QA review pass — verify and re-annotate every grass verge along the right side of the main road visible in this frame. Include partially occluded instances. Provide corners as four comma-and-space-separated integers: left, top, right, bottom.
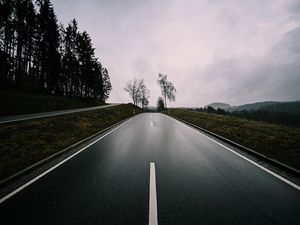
170, 109, 300, 169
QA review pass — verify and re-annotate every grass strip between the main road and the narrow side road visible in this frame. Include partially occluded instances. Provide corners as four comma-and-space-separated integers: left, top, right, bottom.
0, 104, 142, 180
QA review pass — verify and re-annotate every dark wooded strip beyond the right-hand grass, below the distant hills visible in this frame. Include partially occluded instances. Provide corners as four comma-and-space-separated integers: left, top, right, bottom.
192, 106, 300, 127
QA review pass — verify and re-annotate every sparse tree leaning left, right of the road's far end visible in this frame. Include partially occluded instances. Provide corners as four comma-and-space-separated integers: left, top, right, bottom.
157, 73, 176, 108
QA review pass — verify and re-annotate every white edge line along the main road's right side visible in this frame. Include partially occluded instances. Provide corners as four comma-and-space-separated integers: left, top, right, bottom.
177, 120, 300, 191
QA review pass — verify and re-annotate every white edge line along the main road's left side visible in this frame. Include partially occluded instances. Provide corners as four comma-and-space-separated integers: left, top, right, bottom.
0, 118, 133, 204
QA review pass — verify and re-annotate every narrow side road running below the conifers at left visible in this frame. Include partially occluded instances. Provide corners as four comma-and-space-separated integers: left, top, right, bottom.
0, 104, 120, 124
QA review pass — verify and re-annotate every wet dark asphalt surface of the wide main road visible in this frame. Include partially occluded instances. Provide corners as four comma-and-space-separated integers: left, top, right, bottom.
0, 113, 300, 225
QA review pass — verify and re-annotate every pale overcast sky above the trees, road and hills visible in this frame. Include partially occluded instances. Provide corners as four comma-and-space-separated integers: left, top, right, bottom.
52, 0, 300, 107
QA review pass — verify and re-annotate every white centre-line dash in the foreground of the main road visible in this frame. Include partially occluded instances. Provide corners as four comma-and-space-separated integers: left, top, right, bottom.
149, 162, 158, 225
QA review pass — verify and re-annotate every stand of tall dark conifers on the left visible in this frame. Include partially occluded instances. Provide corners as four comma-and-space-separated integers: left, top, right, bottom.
0, 0, 112, 102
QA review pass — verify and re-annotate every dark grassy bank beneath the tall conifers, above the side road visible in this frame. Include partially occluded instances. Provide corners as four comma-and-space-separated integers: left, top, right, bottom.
0, 90, 104, 116
